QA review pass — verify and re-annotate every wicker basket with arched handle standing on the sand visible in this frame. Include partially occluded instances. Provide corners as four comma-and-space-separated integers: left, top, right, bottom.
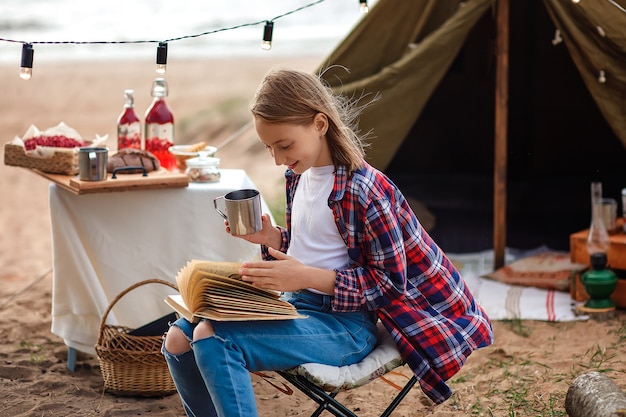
95, 279, 177, 397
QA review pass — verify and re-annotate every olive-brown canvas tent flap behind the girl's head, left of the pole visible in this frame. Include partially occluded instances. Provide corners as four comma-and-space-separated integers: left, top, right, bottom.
317, 0, 491, 170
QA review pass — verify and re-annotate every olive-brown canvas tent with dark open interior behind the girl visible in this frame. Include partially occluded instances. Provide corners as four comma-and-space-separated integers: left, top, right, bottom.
317, 0, 626, 260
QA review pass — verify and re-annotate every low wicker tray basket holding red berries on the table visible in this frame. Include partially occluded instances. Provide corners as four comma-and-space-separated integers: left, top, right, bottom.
4, 143, 78, 175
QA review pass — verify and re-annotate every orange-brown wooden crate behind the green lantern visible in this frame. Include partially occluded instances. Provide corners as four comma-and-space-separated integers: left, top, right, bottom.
569, 219, 626, 308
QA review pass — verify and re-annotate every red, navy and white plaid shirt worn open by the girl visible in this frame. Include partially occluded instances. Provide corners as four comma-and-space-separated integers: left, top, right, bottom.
263, 163, 493, 403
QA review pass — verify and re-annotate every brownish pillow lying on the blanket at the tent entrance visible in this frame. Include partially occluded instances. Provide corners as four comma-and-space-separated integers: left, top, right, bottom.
483, 251, 587, 291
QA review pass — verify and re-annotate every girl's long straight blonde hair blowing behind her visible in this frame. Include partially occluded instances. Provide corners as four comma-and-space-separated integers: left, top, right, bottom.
250, 68, 365, 172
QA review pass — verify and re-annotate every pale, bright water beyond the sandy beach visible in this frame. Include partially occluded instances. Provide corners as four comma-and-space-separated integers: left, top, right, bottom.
0, 0, 375, 65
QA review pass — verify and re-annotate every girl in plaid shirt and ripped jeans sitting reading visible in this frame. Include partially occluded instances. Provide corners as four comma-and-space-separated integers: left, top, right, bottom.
163, 69, 493, 417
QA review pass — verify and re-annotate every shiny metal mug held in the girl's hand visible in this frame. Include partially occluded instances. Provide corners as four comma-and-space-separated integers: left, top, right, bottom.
213, 189, 263, 236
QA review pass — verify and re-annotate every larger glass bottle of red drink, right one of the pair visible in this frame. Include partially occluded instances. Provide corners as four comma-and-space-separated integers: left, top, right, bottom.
144, 78, 176, 171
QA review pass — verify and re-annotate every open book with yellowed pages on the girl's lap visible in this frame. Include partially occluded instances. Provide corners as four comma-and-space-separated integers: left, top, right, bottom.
165, 260, 305, 322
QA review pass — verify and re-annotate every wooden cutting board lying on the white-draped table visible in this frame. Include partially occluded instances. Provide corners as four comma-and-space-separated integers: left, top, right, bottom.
32, 168, 189, 194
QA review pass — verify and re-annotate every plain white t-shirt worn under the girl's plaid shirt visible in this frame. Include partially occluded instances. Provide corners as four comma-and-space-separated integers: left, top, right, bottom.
287, 165, 349, 269
